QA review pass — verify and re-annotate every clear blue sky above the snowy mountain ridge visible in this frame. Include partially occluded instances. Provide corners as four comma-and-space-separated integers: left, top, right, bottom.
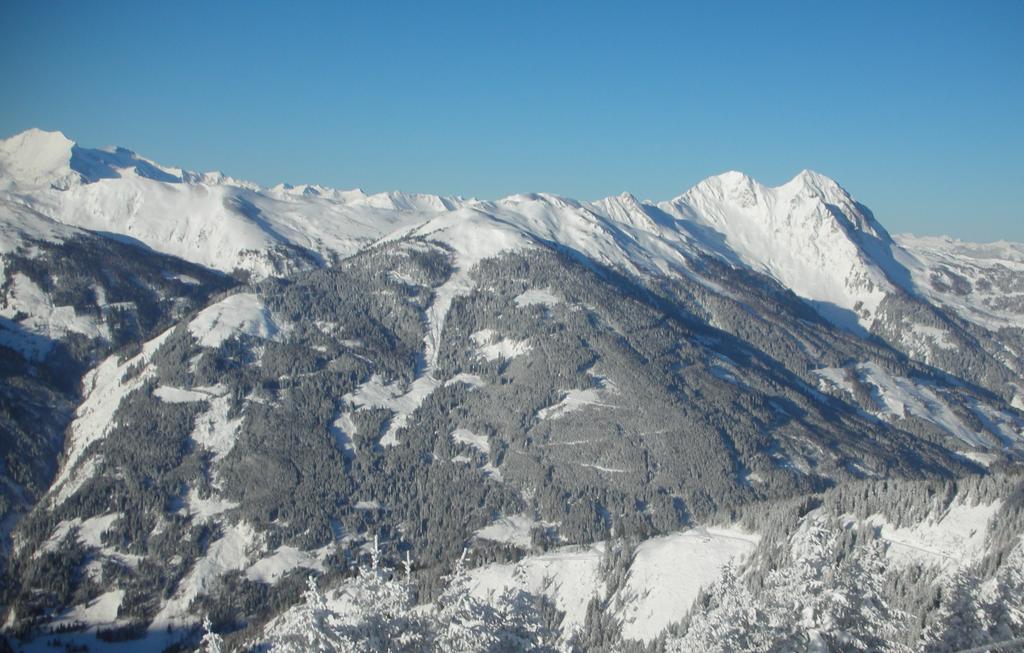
0, 0, 1024, 241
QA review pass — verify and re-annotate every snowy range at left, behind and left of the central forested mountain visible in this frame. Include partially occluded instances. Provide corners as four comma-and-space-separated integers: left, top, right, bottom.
0, 130, 459, 276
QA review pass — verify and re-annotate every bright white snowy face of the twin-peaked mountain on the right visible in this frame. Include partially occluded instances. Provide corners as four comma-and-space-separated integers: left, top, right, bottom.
658, 170, 898, 329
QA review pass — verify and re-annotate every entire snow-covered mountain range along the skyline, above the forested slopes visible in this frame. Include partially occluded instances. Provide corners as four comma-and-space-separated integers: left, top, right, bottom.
0, 130, 1024, 398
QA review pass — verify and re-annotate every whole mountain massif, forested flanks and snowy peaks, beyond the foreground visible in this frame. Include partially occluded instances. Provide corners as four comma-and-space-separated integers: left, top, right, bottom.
0, 131, 1024, 650
